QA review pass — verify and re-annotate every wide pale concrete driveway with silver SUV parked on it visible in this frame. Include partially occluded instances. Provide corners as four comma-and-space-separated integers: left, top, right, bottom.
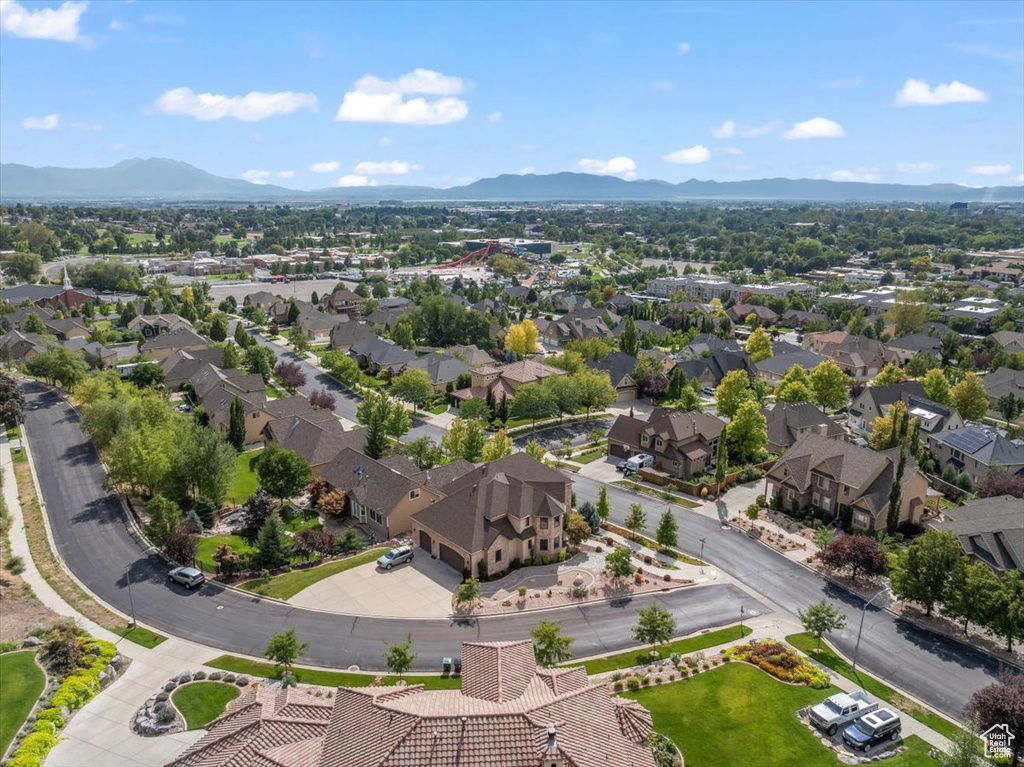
288, 551, 462, 617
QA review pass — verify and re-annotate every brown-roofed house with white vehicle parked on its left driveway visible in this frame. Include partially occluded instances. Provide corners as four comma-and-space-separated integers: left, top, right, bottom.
608, 408, 725, 479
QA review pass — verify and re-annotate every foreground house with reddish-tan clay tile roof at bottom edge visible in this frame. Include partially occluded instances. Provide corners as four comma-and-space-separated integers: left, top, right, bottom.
167, 639, 655, 767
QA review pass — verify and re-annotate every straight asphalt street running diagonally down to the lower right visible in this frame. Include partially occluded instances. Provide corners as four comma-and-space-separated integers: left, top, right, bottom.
565, 472, 1001, 717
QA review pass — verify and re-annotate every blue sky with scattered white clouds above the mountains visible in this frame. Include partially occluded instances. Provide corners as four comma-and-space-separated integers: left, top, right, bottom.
0, 0, 1024, 188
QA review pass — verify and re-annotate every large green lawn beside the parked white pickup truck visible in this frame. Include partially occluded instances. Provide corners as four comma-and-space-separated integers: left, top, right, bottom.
626, 663, 938, 767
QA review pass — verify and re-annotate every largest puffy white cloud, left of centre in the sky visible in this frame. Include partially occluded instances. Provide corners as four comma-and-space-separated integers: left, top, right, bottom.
334, 70, 469, 125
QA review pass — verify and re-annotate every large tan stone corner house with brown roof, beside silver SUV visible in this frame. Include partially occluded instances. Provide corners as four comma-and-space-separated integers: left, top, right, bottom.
412, 453, 572, 574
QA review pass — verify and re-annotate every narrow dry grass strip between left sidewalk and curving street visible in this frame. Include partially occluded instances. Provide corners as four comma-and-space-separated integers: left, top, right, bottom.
14, 454, 167, 647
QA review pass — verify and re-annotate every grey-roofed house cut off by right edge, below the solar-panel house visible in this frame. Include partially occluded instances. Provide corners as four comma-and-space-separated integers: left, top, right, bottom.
932, 496, 1024, 572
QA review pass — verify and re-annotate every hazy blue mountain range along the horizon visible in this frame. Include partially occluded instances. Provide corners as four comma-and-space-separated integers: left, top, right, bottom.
0, 158, 1024, 203
